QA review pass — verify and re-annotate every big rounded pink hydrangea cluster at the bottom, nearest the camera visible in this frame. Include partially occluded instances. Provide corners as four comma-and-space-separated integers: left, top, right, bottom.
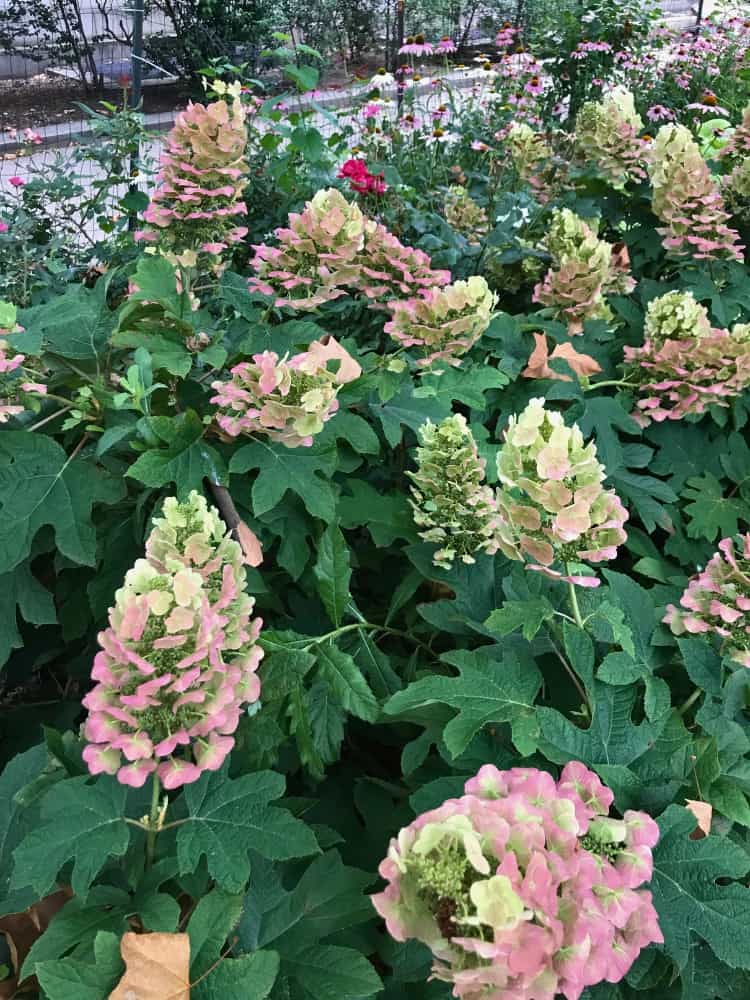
372, 761, 663, 1000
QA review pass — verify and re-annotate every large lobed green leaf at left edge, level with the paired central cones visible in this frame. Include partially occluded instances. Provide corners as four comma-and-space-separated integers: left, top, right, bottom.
0, 430, 123, 573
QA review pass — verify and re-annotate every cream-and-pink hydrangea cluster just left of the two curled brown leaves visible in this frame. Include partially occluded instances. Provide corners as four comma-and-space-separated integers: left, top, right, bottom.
384, 274, 497, 367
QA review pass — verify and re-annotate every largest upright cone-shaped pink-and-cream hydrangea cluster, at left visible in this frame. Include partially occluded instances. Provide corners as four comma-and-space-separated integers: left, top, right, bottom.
83, 490, 263, 789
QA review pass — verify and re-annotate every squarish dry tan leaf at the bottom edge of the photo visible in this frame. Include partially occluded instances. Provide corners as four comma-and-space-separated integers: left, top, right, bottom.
109, 932, 190, 1000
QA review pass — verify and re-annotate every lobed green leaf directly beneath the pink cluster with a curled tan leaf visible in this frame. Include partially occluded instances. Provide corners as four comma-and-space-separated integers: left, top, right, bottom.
229, 441, 337, 522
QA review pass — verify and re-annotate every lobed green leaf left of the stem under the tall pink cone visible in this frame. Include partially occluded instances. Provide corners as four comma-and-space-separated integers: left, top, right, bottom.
13, 776, 130, 899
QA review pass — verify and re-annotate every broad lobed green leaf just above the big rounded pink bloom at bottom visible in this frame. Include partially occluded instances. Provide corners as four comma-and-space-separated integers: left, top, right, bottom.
384, 649, 542, 757
